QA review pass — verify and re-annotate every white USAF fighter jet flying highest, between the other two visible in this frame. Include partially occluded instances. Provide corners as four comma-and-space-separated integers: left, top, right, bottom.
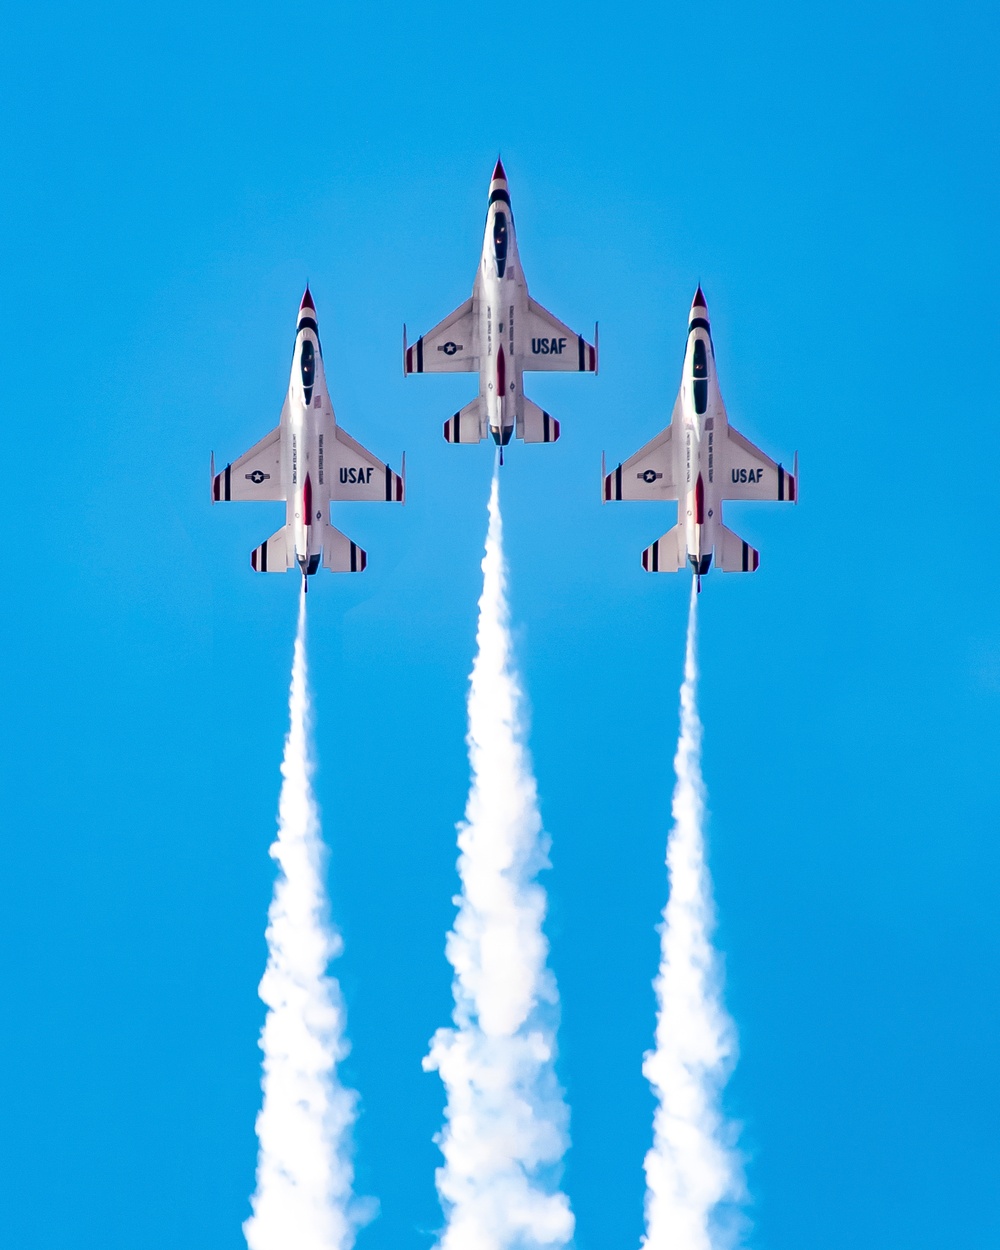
403, 160, 598, 464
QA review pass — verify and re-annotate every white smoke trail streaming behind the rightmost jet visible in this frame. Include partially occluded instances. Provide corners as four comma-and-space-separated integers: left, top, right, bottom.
643, 583, 745, 1250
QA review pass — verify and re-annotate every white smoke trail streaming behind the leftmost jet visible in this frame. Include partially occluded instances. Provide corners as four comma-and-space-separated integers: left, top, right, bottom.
244, 591, 361, 1250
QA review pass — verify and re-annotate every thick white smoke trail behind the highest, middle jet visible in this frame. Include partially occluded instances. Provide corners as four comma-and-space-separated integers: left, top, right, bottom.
424, 469, 574, 1250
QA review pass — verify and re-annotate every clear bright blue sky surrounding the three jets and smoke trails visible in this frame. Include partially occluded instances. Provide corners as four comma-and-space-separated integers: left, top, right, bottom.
0, 0, 1000, 1250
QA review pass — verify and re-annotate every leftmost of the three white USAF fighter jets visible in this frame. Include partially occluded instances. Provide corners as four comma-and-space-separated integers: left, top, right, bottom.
211, 286, 406, 590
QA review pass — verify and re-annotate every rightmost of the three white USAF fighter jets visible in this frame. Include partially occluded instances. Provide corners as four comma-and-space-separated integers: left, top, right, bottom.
601, 286, 799, 590
